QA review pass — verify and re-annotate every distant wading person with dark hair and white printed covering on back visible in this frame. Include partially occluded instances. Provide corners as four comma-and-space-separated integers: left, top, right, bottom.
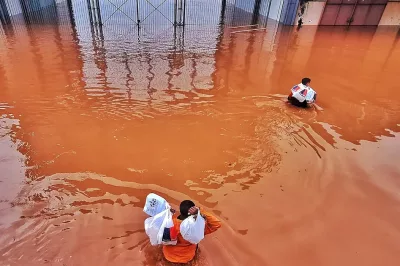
288, 78, 317, 107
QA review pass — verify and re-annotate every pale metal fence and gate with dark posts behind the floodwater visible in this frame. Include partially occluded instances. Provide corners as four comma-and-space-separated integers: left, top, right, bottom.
0, 0, 274, 27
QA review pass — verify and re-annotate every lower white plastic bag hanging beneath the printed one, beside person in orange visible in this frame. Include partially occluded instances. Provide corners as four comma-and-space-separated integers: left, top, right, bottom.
144, 207, 177, 246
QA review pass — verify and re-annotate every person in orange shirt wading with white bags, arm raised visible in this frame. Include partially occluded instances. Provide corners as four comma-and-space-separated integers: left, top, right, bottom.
163, 200, 221, 263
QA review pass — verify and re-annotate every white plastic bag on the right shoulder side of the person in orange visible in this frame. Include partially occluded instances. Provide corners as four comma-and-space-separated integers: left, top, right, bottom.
180, 210, 206, 244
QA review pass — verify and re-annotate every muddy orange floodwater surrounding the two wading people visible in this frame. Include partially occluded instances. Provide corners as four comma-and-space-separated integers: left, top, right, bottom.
0, 20, 400, 266
